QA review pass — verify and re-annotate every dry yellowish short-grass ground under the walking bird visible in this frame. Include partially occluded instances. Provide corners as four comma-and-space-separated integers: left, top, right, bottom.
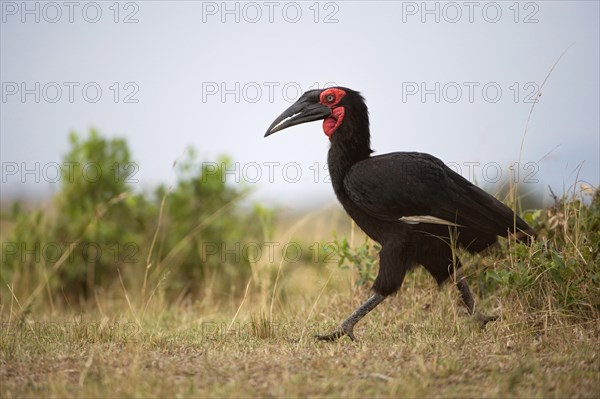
0, 266, 600, 397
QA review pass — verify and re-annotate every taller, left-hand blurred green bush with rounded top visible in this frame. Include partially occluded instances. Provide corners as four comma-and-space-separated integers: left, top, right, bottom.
53, 130, 149, 297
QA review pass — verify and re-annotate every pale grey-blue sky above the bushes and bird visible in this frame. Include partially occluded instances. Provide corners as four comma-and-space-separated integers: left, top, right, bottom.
0, 1, 600, 208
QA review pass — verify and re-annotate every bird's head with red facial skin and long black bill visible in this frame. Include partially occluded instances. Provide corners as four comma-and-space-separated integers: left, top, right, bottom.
265, 87, 368, 139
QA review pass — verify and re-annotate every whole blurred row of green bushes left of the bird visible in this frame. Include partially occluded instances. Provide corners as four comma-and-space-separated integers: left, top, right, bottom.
0, 130, 271, 301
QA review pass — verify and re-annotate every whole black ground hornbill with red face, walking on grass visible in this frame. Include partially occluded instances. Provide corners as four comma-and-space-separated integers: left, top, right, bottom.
265, 87, 535, 341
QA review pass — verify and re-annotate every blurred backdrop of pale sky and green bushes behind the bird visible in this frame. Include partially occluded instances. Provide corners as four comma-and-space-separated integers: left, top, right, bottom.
0, 1, 600, 309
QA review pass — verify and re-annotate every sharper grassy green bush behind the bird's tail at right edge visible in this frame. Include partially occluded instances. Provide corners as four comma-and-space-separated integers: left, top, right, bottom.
479, 190, 600, 315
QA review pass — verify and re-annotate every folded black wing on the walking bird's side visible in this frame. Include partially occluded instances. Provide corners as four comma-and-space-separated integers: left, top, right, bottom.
344, 152, 533, 236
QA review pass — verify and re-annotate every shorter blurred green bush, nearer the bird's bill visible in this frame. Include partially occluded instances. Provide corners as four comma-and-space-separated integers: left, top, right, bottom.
151, 151, 271, 291
